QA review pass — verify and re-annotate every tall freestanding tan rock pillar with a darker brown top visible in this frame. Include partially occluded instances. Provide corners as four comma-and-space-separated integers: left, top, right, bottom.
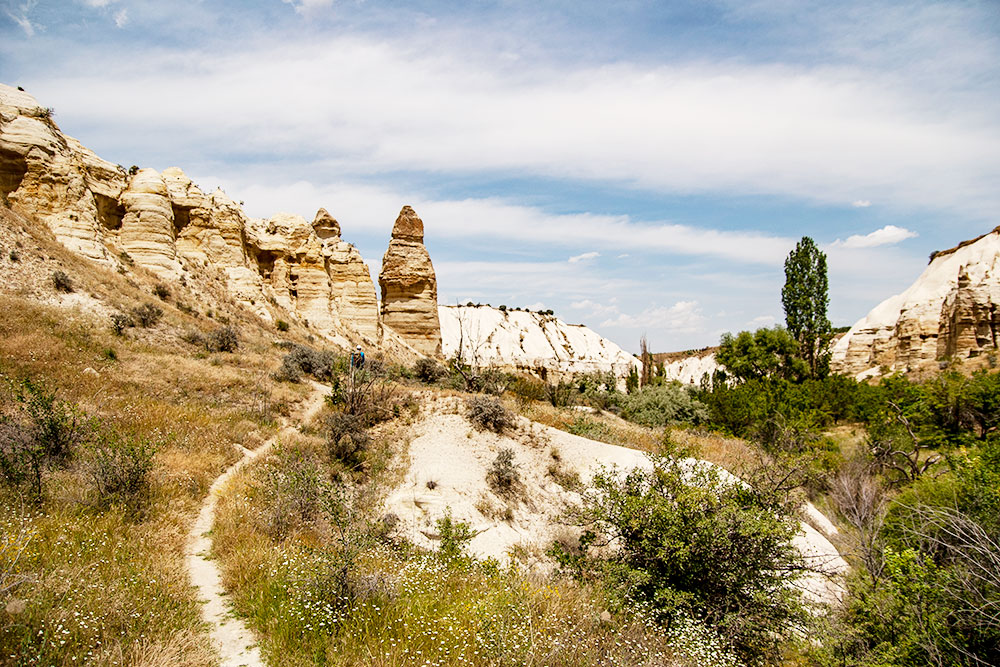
378, 206, 441, 356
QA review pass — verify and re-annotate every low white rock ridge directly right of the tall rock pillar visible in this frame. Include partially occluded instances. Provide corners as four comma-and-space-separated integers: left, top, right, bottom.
438, 306, 642, 380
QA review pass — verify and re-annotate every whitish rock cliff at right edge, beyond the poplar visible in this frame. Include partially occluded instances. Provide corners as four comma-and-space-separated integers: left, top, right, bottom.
830, 227, 1000, 377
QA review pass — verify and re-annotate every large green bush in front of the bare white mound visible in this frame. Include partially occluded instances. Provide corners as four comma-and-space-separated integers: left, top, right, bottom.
553, 456, 809, 664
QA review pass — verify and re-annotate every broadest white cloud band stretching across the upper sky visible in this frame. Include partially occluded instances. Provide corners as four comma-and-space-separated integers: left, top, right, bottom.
34, 34, 1000, 215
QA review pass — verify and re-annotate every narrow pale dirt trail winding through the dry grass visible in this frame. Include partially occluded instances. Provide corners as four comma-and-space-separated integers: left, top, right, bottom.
185, 382, 328, 667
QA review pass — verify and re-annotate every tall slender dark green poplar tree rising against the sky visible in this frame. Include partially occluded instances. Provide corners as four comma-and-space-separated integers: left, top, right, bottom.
781, 236, 833, 377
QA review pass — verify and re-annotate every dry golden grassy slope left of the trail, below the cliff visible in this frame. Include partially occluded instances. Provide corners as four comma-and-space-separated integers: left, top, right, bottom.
0, 207, 320, 665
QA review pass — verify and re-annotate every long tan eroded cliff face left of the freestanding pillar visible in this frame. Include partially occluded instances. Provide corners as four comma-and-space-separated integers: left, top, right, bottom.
0, 84, 378, 343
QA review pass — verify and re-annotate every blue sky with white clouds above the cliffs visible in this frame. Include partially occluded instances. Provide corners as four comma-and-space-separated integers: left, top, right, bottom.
0, 0, 1000, 352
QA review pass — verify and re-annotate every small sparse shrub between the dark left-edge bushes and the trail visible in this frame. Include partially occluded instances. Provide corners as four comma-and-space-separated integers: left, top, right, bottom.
85, 433, 156, 504
